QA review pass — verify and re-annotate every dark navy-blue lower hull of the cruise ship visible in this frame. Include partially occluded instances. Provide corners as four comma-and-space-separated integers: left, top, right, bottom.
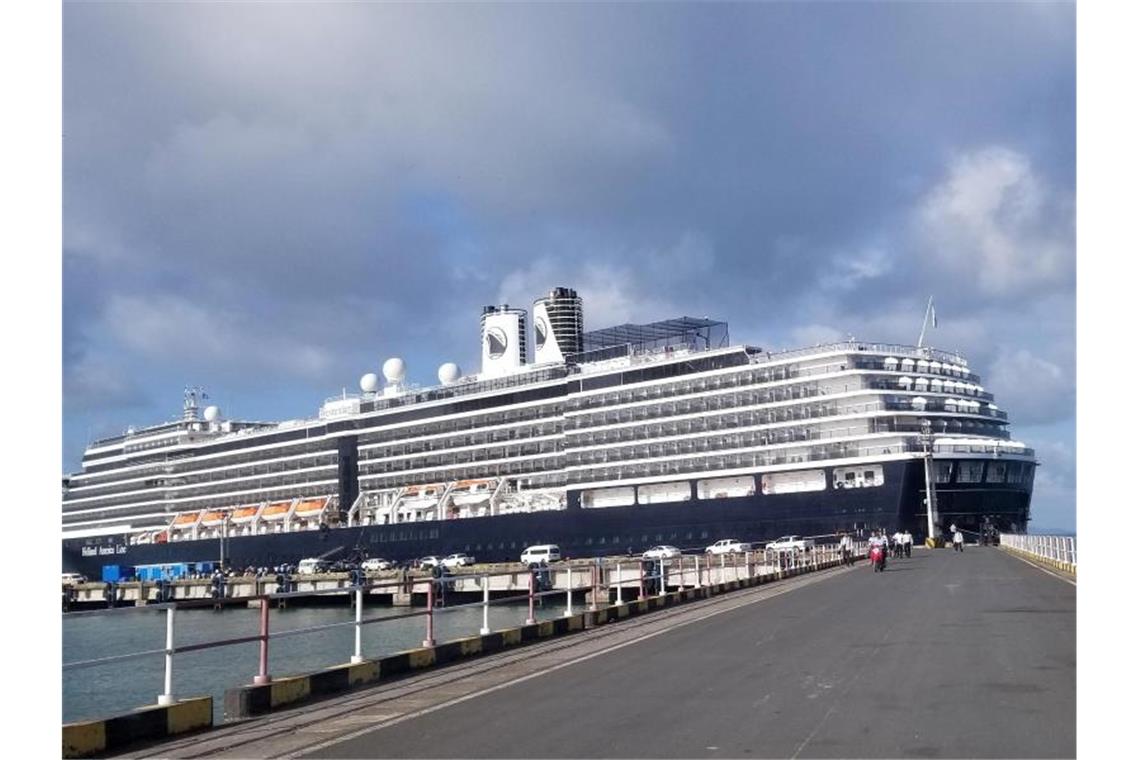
63, 460, 1033, 578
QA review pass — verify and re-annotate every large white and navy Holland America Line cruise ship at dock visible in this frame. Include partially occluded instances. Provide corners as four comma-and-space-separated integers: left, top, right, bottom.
63, 287, 1036, 575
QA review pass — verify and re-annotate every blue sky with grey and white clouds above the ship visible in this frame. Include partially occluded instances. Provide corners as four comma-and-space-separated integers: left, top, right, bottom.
62, 2, 1076, 530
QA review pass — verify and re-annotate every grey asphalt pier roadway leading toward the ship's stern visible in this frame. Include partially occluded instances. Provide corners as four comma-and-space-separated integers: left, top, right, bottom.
140, 547, 1076, 758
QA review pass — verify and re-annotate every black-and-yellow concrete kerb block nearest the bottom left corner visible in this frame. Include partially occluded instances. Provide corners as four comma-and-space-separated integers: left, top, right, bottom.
63, 696, 213, 758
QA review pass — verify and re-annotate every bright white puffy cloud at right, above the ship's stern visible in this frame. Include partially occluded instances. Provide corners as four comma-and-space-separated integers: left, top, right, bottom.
914, 146, 1075, 297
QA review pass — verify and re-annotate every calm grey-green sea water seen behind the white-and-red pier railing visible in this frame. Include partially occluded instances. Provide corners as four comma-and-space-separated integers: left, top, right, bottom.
63, 597, 583, 725
